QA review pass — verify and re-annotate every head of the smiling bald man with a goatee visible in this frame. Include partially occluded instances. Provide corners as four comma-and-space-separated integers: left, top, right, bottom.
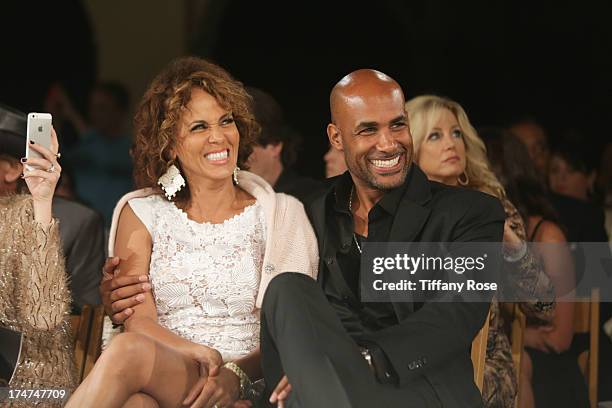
327, 69, 412, 191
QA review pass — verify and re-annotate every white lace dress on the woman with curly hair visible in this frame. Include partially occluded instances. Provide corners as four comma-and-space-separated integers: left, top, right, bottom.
129, 195, 266, 361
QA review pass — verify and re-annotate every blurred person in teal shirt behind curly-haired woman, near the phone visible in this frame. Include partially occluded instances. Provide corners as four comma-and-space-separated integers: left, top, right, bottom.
59, 82, 133, 228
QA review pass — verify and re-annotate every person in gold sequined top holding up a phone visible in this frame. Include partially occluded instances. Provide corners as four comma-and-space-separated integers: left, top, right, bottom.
0, 124, 76, 398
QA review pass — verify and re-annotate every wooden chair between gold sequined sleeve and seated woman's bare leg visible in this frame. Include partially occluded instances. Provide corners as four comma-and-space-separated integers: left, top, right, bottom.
70, 305, 104, 383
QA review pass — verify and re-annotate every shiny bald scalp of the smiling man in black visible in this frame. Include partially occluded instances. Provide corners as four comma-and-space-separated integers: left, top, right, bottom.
329, 69, 404, 123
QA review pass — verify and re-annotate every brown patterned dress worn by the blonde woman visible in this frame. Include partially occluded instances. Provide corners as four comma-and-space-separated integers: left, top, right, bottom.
482, 198, 554, 408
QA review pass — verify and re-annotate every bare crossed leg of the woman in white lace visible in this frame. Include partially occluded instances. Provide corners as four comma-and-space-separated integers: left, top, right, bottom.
66, 333, 199, 408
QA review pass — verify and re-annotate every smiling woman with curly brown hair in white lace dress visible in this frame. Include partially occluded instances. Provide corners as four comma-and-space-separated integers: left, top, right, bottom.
68, 57, 318, 407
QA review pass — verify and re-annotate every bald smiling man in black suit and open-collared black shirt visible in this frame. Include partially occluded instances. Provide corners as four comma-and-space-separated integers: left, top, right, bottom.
261, 70, 504, 408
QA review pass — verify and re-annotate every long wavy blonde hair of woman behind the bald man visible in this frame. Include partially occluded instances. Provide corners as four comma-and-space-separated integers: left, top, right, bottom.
406, 95, 506, 198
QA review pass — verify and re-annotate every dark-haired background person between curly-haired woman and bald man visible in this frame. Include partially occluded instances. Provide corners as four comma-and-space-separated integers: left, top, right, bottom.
246, 87, 322, 202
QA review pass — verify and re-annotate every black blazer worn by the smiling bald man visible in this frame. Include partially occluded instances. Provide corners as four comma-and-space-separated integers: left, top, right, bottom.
307, 165, 505, 407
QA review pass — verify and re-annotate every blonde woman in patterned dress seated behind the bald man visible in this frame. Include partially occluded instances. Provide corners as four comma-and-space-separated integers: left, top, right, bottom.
406, 95, 554, 407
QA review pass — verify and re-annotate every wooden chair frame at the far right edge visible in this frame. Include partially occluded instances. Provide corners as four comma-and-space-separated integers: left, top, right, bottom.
574, 288, 599, 408
